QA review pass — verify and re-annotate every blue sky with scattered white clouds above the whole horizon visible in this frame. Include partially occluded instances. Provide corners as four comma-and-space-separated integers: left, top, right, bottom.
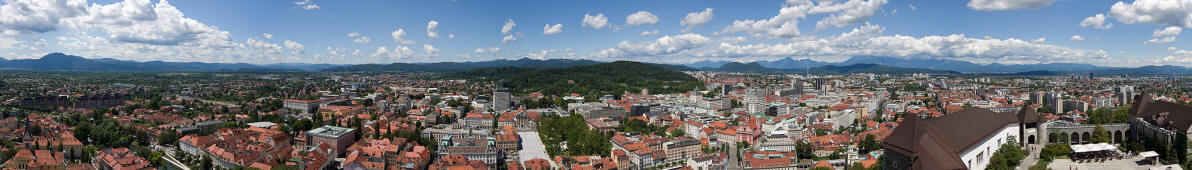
0, 0, 1192, 67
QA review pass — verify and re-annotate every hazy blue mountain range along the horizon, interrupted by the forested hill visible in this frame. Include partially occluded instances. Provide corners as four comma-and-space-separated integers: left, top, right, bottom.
0, 52, 1192, 75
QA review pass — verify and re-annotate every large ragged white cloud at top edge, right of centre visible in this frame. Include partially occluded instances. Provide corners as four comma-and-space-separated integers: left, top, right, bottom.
719, 0, 887, 38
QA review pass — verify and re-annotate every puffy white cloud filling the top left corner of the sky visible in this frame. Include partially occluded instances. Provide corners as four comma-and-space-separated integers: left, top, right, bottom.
0, 0, 87, 32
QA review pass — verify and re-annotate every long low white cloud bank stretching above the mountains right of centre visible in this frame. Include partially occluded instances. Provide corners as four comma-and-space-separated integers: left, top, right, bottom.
702, 25, 1107, 63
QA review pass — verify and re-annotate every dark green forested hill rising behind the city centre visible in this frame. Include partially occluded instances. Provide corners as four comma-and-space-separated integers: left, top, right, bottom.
507, 61, 703, 97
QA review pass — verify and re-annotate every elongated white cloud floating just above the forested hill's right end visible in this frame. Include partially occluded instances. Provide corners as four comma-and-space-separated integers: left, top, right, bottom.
597, 33, 710, 57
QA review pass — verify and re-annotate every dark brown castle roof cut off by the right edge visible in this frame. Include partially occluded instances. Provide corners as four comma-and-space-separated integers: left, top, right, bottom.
1130, 93, 1192, 132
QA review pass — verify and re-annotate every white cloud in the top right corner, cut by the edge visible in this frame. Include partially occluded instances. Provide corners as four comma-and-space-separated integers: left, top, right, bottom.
1109, 0, 1192, 27
